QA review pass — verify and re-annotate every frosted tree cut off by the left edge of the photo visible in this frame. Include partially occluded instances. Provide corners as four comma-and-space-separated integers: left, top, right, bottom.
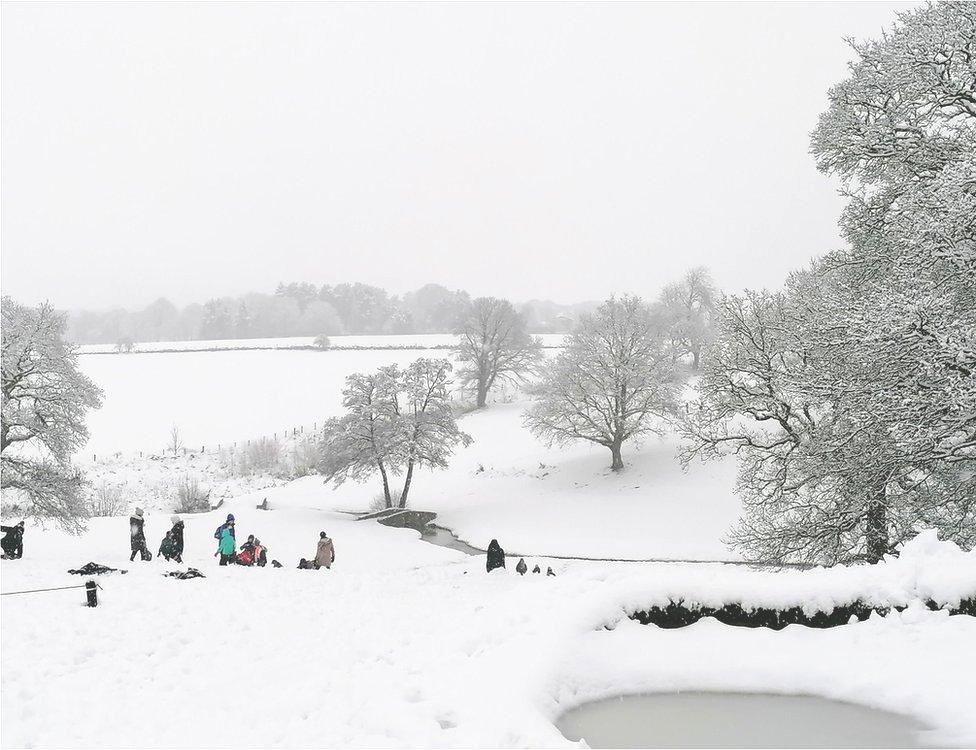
0, 296, 101, 531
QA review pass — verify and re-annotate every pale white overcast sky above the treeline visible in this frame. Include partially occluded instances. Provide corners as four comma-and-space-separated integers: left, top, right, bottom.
2, 3, 912, 308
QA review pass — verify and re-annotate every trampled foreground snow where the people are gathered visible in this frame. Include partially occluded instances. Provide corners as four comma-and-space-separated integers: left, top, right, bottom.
0, 478, 976, 748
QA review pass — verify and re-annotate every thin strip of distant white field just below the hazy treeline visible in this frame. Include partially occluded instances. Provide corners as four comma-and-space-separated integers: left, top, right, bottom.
78, 333, 564, 354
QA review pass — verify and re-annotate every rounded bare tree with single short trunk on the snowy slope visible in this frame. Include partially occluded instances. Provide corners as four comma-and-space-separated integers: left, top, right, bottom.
524, 297, 676, 471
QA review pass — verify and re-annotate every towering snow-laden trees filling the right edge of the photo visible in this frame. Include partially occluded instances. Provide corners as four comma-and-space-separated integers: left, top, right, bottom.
686, 2, 976, 562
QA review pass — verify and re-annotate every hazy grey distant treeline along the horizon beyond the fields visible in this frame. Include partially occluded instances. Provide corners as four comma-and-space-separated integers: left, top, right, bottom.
68, 282, 595, 344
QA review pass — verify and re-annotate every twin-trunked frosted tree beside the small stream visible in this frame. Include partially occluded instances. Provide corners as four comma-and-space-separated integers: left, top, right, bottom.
320, 358, 471, 508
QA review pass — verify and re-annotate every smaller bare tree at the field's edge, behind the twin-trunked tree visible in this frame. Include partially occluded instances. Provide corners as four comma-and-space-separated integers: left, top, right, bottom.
454, 297, 542, 408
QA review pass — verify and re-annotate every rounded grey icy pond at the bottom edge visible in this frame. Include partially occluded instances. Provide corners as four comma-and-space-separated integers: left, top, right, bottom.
556, 692, 933, 748
